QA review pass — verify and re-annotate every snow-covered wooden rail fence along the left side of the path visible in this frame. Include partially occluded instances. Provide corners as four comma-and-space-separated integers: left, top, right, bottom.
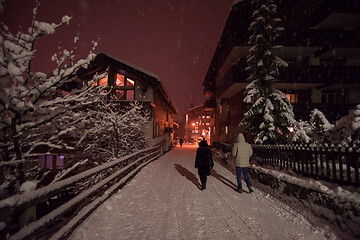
0, 145, 161, 239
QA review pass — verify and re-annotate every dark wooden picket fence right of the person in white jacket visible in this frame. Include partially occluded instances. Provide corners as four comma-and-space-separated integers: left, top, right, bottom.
252, 145, 360, 187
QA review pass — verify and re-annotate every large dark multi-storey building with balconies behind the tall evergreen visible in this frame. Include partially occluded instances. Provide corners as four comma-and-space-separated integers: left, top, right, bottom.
203, 0, 360, 144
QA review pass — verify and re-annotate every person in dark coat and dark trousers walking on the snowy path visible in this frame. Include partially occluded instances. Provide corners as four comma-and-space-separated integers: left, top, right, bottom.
195, 139, 214, 190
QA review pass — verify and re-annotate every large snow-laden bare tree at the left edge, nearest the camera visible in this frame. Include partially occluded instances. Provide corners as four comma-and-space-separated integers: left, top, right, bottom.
0, 2, 97, 187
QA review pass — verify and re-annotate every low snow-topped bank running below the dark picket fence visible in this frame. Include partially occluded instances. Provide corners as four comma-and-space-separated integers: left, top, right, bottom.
249, 165, 360, 239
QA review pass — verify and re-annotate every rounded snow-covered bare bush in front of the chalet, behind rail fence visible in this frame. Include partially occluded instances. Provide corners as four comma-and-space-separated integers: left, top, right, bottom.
74, 96, 149, 164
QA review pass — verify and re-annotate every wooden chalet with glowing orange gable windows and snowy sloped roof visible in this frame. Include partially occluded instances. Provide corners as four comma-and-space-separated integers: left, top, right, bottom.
77, 53, 178, 151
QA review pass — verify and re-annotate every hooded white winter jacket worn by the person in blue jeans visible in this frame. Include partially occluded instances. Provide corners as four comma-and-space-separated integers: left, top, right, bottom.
232, 133, 252, 167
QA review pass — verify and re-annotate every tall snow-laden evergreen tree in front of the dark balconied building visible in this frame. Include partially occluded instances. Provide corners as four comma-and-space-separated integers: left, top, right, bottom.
241, 0, 295, 143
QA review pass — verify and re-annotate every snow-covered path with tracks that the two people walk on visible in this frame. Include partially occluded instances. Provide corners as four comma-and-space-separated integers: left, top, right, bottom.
70, 145, 336, 240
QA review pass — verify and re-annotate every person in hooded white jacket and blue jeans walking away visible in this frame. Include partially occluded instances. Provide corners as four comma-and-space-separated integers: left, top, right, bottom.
232, 133, 253, 193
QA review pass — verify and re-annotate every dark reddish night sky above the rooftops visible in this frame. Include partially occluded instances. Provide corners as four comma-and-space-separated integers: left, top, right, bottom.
1, 0, 234, 119
